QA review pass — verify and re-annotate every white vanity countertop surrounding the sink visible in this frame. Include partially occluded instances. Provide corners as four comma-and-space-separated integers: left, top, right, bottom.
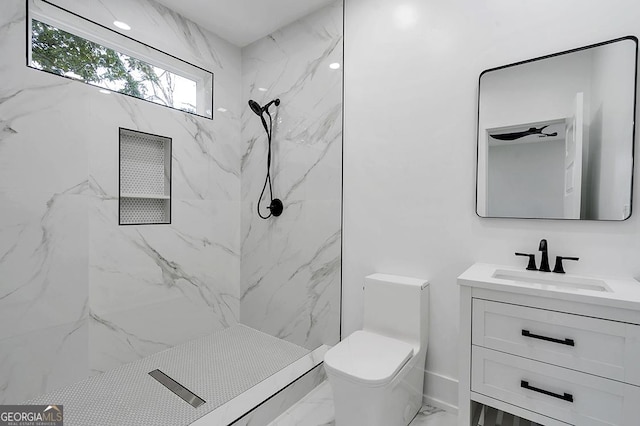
458, 263, 640, 310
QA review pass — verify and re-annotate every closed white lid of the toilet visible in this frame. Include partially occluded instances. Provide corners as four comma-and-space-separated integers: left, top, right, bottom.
324, 330, 413, 384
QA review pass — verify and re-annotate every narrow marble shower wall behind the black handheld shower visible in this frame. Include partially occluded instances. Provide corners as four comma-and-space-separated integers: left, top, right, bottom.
240, 1, 343, 349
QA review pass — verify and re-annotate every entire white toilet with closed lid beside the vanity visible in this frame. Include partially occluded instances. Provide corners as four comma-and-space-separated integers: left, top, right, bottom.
324, 274, 429, 426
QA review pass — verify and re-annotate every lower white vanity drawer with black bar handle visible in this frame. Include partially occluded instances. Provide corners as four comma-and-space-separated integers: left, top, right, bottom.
471, 346, 640, 426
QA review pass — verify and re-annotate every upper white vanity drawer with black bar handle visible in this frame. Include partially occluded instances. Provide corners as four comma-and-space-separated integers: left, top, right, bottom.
472, 299, 640, 385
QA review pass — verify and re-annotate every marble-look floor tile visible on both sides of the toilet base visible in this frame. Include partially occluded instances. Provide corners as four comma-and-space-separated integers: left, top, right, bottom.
269, 381, 458, 426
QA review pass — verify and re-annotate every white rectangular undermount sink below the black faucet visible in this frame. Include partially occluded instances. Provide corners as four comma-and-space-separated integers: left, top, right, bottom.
492, 269, 612, 292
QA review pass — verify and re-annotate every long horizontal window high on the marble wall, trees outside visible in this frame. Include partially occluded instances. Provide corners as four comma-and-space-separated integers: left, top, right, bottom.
28, 1, 213, 118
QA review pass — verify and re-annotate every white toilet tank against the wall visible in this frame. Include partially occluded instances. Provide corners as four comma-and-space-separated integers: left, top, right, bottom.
363, 274, 429, 350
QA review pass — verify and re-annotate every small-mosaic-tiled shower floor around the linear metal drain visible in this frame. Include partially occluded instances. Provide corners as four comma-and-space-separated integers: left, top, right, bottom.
28, 325, 309, 426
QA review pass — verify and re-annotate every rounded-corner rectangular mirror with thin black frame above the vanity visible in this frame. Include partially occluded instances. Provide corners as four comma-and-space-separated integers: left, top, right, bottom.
476, 36, 638, 220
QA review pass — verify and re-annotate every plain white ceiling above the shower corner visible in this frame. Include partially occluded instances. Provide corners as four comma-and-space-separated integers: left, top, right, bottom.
156, 0, 335, 47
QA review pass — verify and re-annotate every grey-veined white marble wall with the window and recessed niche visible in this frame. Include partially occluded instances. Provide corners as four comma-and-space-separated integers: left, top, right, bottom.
0, 0, 241, 404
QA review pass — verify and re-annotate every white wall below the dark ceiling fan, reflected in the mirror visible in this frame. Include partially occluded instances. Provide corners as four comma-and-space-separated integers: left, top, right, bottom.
487, 139, 565, 217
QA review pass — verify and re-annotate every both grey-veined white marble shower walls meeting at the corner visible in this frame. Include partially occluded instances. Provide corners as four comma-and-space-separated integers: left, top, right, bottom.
0, 0, 342, 403
